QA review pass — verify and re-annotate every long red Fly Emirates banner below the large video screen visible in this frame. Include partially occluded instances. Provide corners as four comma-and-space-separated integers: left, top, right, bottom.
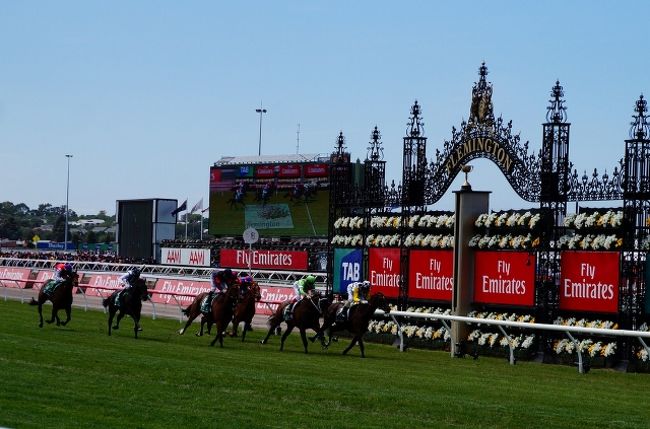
219, 249, 308, 271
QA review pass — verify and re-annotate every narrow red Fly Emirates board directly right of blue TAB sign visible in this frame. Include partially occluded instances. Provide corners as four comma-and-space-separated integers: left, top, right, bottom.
368, 247, 400, 298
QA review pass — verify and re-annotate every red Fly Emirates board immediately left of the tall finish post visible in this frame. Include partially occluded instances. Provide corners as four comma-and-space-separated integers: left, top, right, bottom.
408, 250, 454, 302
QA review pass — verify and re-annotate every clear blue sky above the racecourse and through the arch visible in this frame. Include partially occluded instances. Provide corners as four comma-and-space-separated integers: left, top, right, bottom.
0, 0, 650, 214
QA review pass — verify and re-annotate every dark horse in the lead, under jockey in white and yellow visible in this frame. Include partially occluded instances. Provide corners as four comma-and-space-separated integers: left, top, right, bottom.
310, 292, 390, 358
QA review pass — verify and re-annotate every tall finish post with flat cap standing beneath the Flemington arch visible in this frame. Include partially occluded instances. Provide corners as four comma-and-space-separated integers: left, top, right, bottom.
451, 186, 490, 357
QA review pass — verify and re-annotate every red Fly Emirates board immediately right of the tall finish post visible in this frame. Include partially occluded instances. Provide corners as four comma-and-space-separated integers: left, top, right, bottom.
474, 252, 536, 307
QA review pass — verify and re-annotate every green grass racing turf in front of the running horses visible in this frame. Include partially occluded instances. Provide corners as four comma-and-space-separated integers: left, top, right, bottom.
0, 301, 650, 428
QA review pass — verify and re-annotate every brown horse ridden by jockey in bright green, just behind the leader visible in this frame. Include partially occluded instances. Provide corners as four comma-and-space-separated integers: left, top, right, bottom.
261, 292, 327, 353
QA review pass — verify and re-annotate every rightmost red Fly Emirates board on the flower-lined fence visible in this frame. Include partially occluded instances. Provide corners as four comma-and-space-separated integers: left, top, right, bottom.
560, 251, 620, 313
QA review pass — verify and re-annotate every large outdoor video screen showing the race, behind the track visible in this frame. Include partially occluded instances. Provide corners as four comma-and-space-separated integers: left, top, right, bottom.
209, 163, 329, 237
